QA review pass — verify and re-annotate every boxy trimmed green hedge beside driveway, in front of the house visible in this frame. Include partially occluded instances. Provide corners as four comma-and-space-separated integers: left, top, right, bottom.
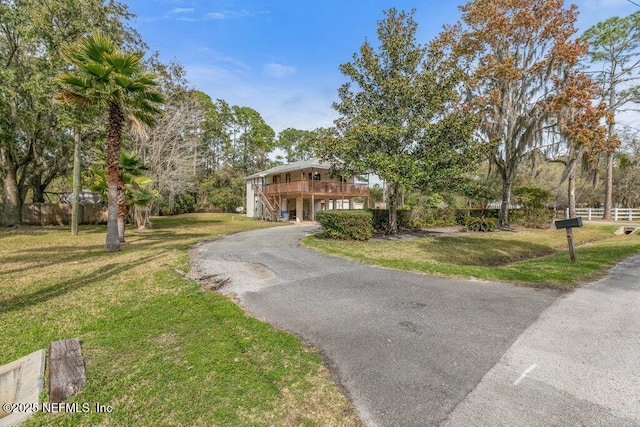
316, 210, 373, 240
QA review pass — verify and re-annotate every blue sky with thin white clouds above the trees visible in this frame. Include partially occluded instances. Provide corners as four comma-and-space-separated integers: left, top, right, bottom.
122, 0, 640, 132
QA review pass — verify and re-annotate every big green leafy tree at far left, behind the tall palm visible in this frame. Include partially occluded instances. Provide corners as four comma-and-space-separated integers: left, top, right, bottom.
0, 0, 141, 225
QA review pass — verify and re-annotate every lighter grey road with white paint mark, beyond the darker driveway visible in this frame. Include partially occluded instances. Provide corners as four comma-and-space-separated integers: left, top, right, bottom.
445, 256, 640, 427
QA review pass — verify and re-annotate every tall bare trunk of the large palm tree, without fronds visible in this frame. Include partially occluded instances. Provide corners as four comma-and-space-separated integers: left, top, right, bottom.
105, 102, 124, 252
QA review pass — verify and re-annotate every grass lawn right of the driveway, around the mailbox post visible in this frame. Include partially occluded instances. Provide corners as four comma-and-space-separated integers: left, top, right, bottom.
304, 225, 640, 289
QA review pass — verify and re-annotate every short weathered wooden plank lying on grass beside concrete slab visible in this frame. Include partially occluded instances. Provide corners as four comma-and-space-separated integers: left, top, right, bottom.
49, 338, 87, 403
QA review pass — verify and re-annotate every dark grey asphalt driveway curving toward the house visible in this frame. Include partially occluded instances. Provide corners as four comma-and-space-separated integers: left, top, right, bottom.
193, 226, 559, 426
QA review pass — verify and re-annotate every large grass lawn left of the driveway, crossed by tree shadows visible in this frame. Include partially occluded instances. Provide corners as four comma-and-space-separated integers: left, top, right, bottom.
0, 214, 359, 426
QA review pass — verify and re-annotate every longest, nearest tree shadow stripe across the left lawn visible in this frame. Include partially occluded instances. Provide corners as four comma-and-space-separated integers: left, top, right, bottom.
0, 254, 168, 314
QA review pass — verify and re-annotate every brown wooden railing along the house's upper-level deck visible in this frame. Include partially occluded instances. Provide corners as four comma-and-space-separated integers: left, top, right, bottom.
264, 181, 369, 197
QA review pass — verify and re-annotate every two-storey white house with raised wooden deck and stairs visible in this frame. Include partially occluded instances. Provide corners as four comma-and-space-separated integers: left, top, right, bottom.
245, 159, 369, 221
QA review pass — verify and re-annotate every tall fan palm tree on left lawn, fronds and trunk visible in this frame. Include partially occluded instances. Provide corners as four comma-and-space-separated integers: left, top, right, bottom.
57, 34, 164, 252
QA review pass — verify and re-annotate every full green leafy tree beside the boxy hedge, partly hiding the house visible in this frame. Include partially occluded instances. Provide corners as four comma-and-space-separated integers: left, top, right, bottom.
318, 9, 482, 233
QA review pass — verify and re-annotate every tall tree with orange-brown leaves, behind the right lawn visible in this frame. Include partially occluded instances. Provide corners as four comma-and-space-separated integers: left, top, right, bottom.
434, 0, 587, 227
